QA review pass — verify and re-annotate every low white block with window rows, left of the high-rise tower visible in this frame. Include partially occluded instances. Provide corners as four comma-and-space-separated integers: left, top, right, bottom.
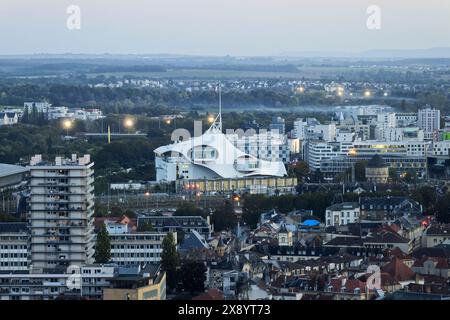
0, 222, 29, 272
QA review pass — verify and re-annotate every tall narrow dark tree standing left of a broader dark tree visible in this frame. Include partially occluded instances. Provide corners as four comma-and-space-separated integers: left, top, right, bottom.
161, 232, 180, 290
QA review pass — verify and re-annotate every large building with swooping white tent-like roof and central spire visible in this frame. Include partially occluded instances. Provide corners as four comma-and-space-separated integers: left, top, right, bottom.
155, 114, 287, 182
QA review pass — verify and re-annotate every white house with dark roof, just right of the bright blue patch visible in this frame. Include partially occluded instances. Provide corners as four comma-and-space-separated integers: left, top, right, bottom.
325, 202, 360, 227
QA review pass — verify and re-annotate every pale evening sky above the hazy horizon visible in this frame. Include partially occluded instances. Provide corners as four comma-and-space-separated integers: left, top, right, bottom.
0, 0, 450, 55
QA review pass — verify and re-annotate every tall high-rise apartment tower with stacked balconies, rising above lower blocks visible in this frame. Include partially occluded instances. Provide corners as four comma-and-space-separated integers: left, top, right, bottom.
27, 155, 94, 270
